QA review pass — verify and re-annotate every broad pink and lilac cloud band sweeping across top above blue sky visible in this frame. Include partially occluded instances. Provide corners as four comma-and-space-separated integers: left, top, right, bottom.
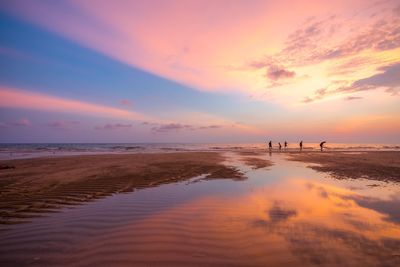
4, 0, 399, 96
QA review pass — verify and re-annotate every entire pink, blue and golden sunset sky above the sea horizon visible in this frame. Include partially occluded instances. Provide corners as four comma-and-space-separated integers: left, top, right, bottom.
0, 0, 400, 144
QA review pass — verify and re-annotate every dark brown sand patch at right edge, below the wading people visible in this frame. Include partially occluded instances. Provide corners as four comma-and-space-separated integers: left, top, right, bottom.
288, 151, 400, 182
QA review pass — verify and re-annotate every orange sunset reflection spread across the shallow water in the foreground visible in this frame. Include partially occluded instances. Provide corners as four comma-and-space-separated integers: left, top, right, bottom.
67, 163, 400, 266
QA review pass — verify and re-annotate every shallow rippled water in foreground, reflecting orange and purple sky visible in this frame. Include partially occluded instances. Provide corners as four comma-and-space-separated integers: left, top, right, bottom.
0, 153, 400, 266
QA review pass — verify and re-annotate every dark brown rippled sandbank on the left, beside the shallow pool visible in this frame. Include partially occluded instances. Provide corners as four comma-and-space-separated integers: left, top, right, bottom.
0, 152, 244, 224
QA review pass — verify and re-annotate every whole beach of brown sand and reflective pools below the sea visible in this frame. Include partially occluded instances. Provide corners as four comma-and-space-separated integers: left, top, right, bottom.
0, 150, 400, 266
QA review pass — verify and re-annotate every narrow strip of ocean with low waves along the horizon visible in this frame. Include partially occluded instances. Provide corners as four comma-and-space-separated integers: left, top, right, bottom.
0, 142, 400, 160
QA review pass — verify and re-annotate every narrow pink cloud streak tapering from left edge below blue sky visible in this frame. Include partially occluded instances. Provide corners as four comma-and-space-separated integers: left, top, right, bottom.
0, 87, 155, 121
